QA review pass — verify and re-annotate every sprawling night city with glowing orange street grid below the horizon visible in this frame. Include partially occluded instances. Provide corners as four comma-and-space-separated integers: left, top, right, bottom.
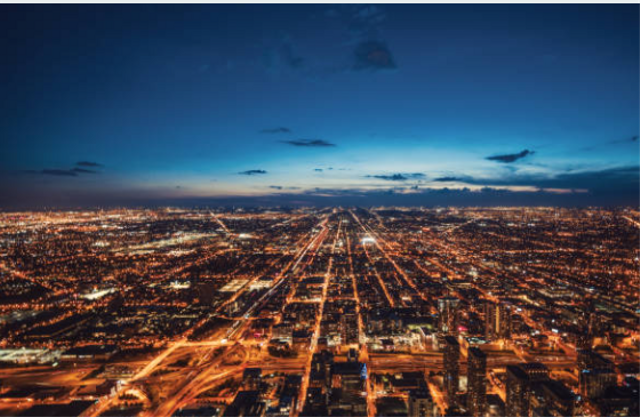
0, 208, 640, 417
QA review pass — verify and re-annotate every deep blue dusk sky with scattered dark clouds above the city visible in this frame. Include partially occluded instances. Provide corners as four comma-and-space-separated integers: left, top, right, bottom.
0, 5, 640, 208
